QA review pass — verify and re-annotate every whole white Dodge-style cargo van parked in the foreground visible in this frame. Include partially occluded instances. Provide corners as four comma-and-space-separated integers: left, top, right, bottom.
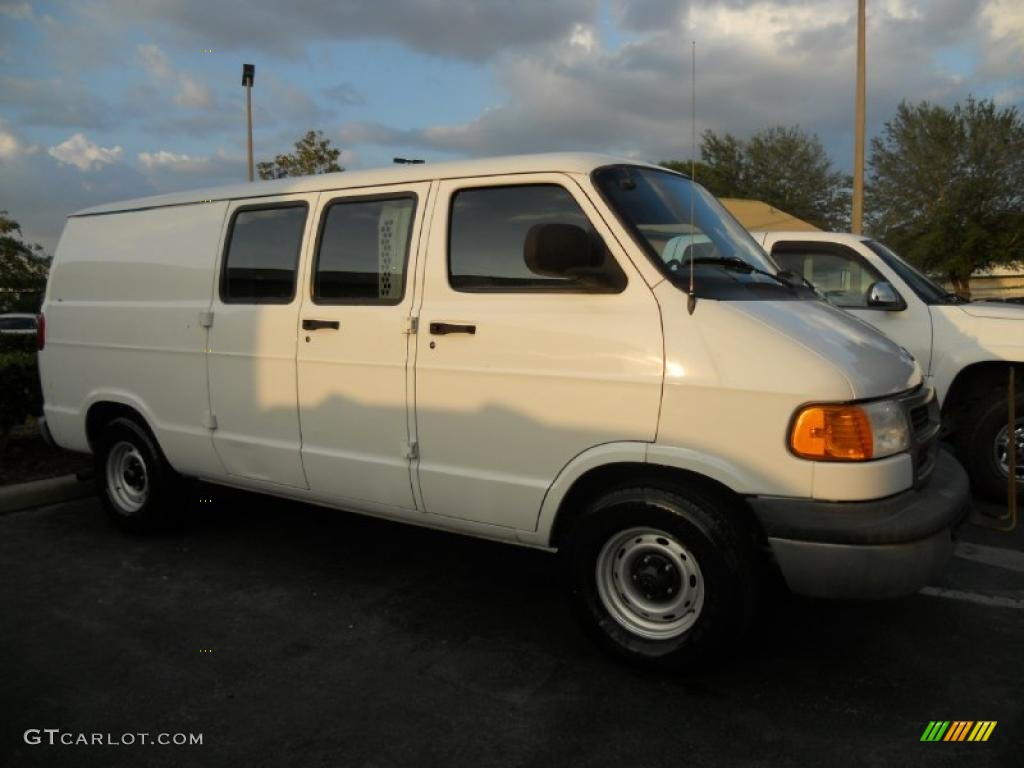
40, 155, 968, 664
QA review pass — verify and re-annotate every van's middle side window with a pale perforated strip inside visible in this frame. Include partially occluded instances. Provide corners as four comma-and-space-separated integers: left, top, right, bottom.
313, 196, 416, 304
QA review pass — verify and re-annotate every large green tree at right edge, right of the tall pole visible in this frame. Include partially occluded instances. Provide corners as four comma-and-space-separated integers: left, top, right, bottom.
867, 97, 1024, 296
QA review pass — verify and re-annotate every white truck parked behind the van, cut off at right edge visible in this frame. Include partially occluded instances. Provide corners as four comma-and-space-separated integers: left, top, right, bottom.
752, 231, 1024, 501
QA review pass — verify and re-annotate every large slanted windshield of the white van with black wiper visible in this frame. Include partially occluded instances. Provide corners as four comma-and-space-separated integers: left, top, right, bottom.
593, 165, 815, 299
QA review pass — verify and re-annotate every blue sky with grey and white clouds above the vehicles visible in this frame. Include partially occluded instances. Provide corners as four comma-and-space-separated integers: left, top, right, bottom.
0, 0, 1024, 249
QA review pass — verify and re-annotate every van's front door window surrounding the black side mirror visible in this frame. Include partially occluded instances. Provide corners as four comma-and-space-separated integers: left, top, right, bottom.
449, 184, 626, 293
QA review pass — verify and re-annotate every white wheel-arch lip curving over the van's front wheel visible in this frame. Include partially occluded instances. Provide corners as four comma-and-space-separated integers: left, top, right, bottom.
532, 441, 746, 546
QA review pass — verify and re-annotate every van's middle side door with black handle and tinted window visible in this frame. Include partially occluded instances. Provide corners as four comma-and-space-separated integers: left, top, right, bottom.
298, 182, 430, 509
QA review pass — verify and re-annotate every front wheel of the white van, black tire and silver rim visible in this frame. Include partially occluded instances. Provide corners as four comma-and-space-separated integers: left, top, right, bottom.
568, 487, 757, 668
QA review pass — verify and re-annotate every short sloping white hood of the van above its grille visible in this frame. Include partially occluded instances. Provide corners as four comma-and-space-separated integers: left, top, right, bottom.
729, 301, 922, 399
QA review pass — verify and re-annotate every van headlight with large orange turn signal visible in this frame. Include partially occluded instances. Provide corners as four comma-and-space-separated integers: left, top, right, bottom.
790, 400, 910, 461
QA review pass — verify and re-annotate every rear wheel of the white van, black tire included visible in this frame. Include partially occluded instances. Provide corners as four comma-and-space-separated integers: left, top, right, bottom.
94, 417, 183, 534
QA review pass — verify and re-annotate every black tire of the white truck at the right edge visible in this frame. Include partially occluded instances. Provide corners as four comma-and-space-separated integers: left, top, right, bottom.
956, 386, 1024, 504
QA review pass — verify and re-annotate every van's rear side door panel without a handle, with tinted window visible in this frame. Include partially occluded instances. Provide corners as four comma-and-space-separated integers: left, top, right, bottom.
207, 194, 317, 488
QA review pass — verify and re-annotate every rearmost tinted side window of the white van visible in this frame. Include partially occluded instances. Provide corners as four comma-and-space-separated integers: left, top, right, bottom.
220, 203, 307, 304
